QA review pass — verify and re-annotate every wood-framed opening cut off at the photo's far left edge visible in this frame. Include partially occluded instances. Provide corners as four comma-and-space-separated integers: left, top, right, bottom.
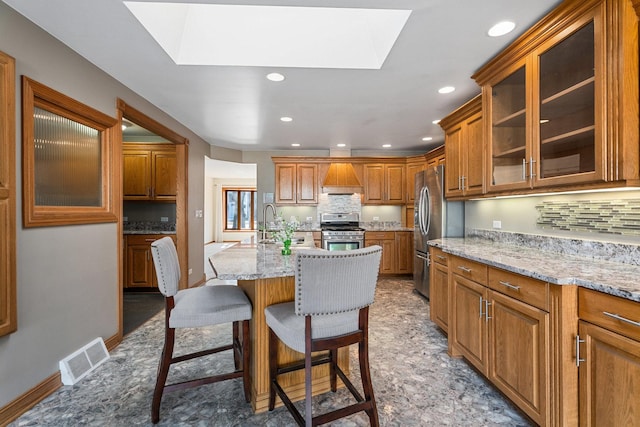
0, 52, 18, 336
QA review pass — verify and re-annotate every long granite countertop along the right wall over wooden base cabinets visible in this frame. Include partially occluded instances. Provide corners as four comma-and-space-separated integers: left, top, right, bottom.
429, 238, 640, 302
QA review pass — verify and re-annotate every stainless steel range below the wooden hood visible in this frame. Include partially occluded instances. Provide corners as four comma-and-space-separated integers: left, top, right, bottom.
320, 212, 364, 251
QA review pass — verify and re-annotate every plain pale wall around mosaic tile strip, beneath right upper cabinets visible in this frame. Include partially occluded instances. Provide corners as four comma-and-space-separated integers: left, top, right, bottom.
465, 190, 640, 244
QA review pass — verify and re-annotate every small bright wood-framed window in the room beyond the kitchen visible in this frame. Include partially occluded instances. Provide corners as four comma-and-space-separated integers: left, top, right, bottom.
222, 188, 258, 231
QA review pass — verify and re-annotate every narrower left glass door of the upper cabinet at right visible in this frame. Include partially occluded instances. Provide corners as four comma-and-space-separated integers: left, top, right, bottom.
489, 64, 529, 187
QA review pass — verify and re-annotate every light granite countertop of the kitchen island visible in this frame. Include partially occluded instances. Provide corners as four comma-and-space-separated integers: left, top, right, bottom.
209, 241, 313, 280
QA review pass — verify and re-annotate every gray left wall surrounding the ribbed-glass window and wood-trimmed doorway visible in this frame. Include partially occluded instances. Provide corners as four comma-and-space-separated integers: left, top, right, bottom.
0, 2, 210, 408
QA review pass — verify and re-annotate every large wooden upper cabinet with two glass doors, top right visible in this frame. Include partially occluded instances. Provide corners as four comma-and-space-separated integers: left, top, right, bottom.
473, 0, 640, 194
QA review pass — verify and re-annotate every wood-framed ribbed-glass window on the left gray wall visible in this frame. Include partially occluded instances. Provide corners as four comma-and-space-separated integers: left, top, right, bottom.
22, 77, 117, 227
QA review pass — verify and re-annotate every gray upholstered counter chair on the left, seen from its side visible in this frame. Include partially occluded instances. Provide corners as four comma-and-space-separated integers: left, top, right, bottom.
151, 237, 251, 423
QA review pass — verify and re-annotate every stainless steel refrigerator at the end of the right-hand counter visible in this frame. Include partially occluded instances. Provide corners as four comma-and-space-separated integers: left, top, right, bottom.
413, 165, 464, 298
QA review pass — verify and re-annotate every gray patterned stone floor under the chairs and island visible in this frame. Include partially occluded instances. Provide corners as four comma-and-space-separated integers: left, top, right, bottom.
9, 279, 530, 427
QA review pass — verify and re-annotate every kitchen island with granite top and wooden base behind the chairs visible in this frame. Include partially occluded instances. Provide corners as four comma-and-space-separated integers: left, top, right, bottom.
210, 242, 349, 412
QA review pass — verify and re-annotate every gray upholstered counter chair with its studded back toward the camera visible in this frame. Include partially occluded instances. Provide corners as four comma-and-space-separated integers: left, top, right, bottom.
265, 246, 382, 426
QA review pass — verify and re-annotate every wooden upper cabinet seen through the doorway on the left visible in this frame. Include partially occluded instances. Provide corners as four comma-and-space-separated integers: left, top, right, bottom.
122, 144, 177, 201
